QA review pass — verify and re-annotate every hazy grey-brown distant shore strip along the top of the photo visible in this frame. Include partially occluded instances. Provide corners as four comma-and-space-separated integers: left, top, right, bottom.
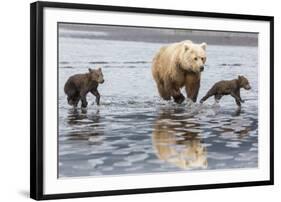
59, 23, 258, 46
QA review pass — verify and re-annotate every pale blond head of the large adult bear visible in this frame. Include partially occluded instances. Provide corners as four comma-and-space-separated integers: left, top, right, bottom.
178, 41, 207, 73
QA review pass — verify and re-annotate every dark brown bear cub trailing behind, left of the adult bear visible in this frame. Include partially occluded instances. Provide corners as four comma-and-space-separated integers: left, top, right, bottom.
64, 68, 104, 108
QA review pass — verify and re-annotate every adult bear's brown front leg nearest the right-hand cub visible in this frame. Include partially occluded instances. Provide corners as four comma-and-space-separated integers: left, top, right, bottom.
185, 75, 200, 102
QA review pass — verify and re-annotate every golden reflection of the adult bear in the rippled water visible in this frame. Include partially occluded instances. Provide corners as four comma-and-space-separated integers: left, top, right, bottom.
152, 109, 208, 169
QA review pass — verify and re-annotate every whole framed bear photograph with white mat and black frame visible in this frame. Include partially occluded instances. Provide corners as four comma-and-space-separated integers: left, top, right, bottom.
30, 2, 274, 200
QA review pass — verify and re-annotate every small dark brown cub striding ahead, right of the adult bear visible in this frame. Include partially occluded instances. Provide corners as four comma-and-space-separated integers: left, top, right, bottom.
200, 76, 251, 107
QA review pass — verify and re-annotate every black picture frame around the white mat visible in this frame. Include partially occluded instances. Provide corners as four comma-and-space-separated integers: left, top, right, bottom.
30, 2, 274, 200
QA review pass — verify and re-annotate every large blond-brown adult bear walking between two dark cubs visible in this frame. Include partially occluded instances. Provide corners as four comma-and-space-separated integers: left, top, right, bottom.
152, 40, 207, 103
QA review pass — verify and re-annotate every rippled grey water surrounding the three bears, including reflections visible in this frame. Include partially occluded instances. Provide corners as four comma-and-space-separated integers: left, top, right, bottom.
58, 28, 258, 177
